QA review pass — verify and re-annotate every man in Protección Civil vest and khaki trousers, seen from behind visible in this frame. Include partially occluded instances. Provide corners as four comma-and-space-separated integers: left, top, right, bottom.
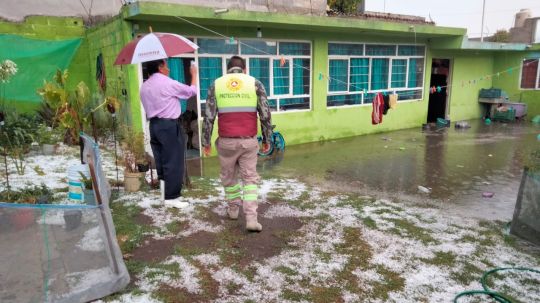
202, 56, 272, 231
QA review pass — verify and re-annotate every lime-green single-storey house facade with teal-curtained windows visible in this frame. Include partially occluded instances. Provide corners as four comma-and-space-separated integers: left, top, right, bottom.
0, 1, 540, 151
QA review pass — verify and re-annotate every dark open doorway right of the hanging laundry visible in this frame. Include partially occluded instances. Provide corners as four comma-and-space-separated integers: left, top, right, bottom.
427, 58, 450, 123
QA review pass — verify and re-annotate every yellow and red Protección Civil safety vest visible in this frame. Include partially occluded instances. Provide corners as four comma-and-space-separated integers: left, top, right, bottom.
215, 73, 257, 137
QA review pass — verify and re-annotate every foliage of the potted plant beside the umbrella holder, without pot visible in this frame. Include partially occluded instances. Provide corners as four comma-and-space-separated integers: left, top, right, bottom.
121, 126, 146, 173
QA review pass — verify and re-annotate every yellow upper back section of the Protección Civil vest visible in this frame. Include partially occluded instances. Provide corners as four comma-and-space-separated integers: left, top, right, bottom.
215, 73, 257, 113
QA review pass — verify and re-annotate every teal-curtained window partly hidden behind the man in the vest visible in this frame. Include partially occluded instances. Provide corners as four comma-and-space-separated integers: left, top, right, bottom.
196, 38, 311, 112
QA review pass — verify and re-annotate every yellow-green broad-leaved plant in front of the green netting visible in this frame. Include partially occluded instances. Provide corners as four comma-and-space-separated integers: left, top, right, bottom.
38, 70, 90, 144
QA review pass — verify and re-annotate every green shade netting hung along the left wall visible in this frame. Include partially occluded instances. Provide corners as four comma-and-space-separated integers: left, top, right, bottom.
0, 34, 81, 103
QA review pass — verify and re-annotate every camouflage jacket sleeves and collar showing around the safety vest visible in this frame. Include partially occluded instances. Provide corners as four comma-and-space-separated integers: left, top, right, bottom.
202, 69, 272, 146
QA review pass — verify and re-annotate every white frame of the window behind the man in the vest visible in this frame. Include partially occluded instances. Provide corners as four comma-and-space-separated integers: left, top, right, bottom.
177, 36, 313, 114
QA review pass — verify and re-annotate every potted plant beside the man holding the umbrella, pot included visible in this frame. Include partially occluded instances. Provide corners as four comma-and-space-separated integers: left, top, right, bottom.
122, 127, 147, 192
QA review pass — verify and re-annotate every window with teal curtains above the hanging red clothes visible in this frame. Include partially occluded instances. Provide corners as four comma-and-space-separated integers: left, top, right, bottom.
327, 43, 426, 107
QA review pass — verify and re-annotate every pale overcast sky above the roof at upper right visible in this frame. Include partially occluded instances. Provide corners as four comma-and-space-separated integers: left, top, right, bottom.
366, 0, 540, 37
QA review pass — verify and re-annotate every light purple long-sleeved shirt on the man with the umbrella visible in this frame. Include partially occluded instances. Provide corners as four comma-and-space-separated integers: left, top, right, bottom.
141, 73, 197, 119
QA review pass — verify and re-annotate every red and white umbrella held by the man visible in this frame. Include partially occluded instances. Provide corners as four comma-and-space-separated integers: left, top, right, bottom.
114, 33, 199, 65
